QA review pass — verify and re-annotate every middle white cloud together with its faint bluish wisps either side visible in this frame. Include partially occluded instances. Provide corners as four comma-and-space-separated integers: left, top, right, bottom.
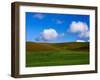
34, 28, 65, 41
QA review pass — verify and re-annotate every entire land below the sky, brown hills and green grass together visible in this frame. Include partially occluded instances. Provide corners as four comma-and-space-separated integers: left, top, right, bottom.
26, 42, 89, 67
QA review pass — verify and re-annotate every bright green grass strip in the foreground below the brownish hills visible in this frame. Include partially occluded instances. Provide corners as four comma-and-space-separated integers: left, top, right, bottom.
26, 50, 89, 67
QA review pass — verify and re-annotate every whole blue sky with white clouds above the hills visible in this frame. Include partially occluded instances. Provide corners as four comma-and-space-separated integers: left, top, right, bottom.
26, 12, 90, 43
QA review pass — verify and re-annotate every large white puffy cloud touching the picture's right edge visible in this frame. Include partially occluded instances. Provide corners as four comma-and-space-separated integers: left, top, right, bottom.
69, 21, 90, 38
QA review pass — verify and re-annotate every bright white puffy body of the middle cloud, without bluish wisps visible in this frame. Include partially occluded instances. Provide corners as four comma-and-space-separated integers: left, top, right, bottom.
42, 28, 58, 40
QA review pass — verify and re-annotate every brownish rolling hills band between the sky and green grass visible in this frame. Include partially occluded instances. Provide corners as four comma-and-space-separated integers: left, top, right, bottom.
26, 42, 89, 51
